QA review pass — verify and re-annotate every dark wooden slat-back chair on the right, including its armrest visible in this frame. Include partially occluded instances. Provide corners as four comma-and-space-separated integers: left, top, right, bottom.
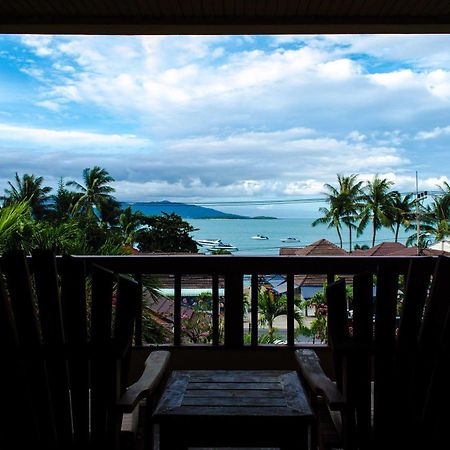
296, 257, 450, 450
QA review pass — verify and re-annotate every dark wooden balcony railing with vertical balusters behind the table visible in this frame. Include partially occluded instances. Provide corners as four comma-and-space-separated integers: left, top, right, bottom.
67, 255, 435, 348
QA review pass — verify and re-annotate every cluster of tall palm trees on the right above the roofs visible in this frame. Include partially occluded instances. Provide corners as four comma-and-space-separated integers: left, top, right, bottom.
312, 174, 450, 252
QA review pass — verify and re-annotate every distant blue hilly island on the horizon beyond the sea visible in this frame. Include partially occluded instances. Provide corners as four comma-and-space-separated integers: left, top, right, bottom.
121, 200, 276, 219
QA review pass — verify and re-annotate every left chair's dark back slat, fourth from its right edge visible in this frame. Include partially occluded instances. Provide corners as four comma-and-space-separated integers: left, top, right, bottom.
33, 250, 73, 448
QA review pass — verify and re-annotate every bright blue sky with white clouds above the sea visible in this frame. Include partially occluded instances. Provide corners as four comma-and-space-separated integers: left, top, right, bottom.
0, 35, 450, 217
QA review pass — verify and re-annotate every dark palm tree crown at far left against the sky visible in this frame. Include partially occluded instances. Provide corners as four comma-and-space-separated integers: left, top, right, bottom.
3, 172, 52, 219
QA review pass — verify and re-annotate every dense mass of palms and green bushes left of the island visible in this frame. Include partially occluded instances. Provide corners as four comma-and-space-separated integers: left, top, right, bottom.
0, 166, 197, 255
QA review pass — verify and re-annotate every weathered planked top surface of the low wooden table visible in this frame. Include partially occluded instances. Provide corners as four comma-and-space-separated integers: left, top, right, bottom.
154, 370, 313, 421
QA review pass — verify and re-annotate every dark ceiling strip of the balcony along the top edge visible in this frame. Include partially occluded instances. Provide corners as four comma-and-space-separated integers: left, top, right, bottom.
0, 0, 450, 34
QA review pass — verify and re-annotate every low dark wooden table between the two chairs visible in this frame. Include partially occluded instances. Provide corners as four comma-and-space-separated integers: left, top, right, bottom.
153, 370, 313, 450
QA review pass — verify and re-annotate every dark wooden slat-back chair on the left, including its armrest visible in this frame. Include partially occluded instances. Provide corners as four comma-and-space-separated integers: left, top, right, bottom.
0, 251, 169, 450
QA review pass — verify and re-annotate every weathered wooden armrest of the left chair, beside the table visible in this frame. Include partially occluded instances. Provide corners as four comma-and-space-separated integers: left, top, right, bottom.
117, 350, 170, 413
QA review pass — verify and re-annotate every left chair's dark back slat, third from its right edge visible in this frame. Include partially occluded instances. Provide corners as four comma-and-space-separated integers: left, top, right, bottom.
59, 257, 90, 449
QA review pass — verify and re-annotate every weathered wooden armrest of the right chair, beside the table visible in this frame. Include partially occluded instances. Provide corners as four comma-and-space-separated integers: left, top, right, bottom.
295, 349, 346, 411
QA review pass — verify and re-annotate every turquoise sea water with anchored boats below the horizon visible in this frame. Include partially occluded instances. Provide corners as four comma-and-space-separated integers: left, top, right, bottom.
184, 219, 411, 256
